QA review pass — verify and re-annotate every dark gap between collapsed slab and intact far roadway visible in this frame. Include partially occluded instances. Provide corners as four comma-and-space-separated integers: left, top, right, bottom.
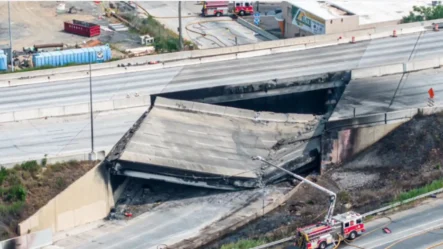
151, 71, 350, 115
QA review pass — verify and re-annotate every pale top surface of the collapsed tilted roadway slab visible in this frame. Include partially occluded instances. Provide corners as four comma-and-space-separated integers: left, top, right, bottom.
117, 97, 319, 187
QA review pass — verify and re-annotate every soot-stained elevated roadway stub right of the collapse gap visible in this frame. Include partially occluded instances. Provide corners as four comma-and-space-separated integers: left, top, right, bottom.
331, 69, 443, 119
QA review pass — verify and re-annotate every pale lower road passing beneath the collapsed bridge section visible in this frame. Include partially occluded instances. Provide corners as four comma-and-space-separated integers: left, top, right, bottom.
50, 183, 290, 249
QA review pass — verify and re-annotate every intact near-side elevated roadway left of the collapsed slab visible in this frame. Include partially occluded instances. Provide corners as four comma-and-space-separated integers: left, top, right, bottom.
0, 107, 146, 164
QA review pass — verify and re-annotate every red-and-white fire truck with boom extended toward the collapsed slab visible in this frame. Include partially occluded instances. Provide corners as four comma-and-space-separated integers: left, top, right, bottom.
252, 156, 365, 249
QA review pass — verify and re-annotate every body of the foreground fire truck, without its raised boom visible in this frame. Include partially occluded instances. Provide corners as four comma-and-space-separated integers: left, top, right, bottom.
295, 211, 365, 249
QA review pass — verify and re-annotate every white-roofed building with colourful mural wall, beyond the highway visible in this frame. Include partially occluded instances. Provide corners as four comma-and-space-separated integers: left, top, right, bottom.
276, 0, 436, 38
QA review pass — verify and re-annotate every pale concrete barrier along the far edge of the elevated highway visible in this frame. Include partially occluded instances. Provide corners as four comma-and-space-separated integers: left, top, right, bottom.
0, 19, 443, 84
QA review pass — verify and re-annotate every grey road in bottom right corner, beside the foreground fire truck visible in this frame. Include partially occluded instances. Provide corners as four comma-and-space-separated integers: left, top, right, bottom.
286, 199, 443, 249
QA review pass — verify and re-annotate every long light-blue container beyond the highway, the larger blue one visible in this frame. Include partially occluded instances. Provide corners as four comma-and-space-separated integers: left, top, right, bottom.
32, 46, 112, 67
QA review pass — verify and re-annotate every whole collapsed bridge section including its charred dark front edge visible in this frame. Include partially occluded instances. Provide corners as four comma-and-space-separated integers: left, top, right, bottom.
108, 97, 323, 189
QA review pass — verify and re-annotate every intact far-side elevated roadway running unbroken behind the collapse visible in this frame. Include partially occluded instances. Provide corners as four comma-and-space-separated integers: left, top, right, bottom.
0, 32, 443, 113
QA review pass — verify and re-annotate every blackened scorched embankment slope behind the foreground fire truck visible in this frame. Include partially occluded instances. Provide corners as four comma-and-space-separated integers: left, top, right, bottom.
210, 115, 443, 249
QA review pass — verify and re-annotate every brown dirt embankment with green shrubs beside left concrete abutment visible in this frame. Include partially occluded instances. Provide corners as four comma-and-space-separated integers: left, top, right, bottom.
0, 161, 97, 240
